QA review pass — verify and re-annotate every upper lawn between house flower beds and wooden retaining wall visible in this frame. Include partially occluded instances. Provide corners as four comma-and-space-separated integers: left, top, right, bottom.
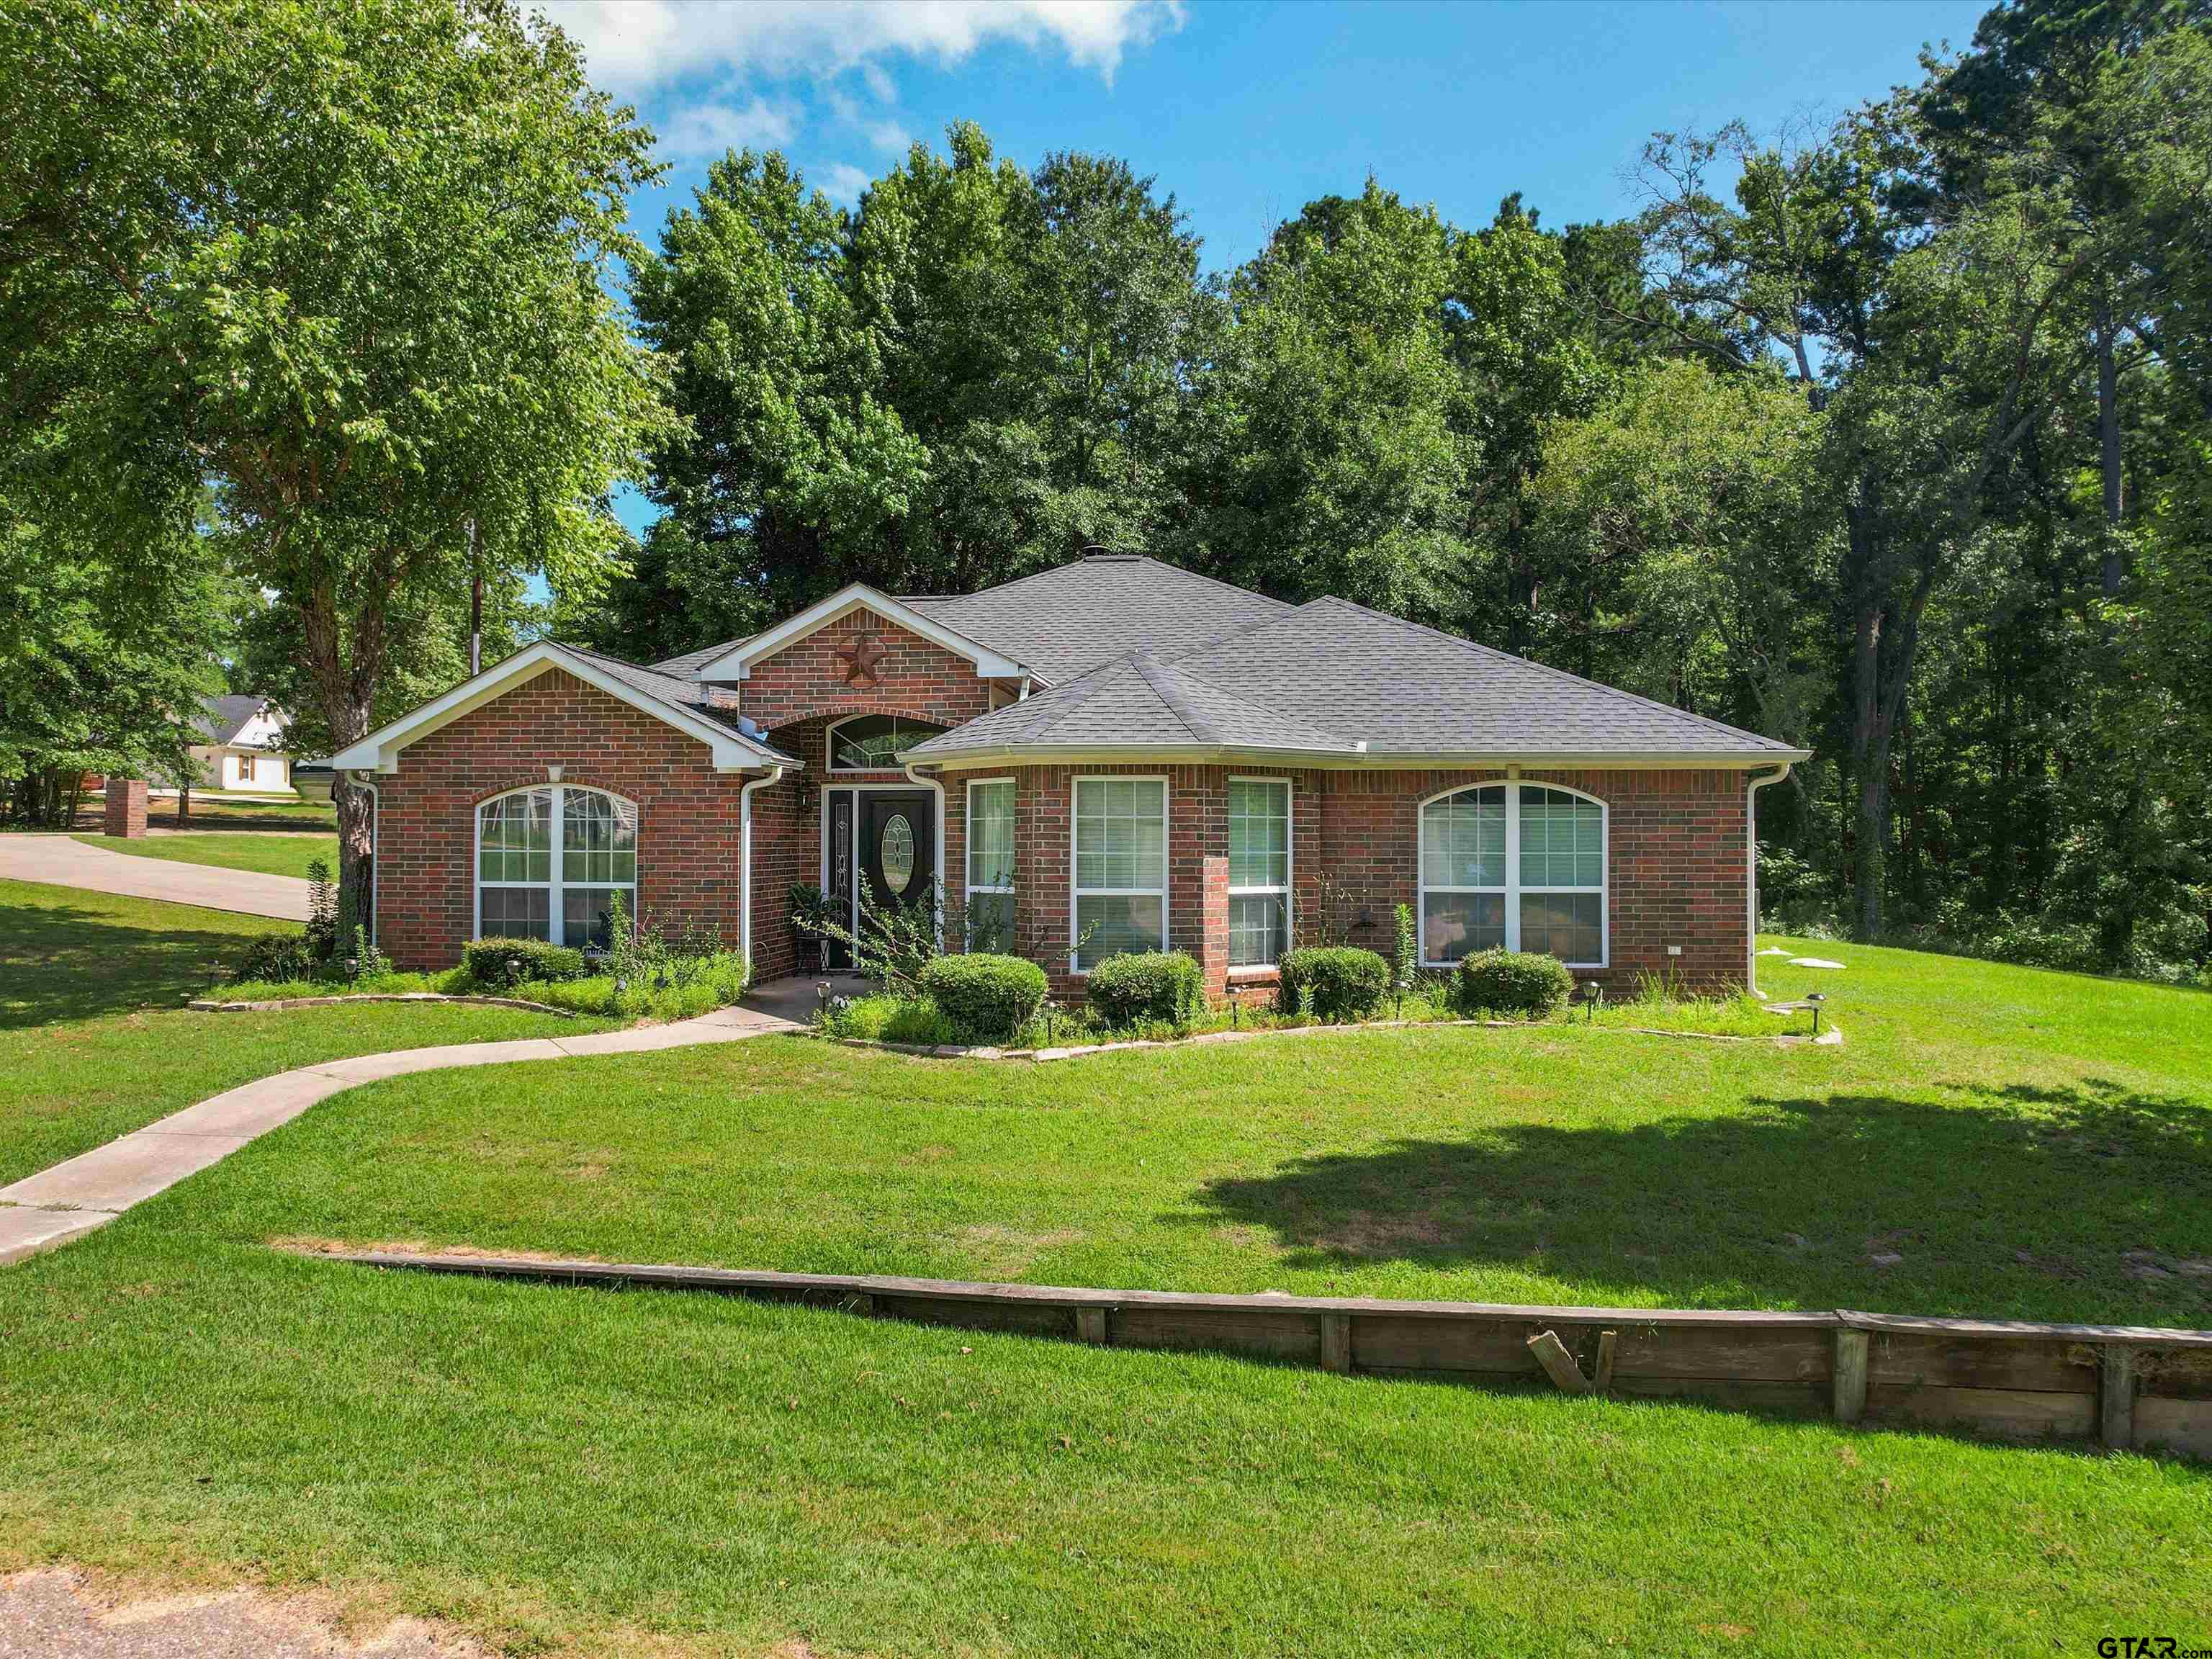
176, 947, 2212, 1327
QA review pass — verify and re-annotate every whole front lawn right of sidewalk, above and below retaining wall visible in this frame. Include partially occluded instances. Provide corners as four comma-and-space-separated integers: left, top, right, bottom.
0, 929, 2212, 1655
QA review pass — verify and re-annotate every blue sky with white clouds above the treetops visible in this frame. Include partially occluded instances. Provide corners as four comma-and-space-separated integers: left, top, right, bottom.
547, 0, 1987, 541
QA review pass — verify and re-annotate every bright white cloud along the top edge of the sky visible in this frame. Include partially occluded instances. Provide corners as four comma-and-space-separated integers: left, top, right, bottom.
544, 0, 1184, 93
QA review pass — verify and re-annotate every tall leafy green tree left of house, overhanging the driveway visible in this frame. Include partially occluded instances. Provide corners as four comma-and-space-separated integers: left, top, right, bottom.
0, 0, 657, 925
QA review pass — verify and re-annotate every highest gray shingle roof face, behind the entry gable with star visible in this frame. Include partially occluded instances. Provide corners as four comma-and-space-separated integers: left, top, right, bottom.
907, 553, 1292, 685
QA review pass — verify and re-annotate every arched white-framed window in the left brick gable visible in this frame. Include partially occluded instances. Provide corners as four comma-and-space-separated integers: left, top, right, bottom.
475, 783, 637, 947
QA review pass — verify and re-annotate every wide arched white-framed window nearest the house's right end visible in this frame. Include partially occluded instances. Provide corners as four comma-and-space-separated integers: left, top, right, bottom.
1420, 783, 1610, 966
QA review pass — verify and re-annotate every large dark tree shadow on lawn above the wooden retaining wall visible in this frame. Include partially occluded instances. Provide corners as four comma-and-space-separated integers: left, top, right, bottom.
1181, 1079, 2212, 1325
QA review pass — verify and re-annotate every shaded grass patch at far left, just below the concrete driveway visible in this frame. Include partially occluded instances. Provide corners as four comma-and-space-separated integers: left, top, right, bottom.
0, 904, 265, 1028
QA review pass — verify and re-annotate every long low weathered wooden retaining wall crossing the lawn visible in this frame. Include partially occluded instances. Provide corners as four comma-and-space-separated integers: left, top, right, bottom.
332, 1250, 2212, 1457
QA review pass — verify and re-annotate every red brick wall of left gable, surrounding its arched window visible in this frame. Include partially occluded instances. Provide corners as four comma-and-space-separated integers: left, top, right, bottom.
376, 668, 745, 969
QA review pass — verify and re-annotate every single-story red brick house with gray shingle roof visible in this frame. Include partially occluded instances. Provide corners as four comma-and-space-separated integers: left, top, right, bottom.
334, 553, 1805, 995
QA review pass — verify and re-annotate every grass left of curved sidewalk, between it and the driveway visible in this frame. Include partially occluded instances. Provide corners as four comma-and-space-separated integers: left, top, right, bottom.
0, 881, 604, 1186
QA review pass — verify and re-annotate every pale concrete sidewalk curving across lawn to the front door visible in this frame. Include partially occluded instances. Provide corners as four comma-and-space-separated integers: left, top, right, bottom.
0, 1007, 803, 1265
